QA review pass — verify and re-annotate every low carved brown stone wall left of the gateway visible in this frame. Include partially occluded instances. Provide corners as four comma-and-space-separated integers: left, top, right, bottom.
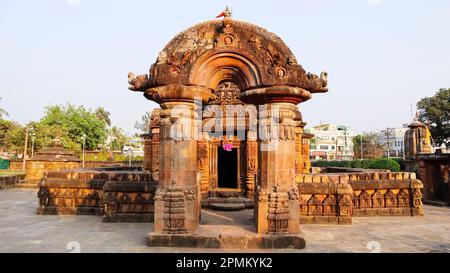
36, 167, 156, 222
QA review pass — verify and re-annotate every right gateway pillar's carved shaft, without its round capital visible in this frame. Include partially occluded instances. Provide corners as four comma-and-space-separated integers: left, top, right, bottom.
256, 103, 299, 233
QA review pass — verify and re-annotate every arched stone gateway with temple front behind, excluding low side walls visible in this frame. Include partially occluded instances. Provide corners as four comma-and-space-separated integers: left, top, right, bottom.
129, 14, 328, 234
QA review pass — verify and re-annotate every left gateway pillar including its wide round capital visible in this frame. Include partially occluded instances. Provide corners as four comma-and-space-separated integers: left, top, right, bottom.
147, 85, 211, 234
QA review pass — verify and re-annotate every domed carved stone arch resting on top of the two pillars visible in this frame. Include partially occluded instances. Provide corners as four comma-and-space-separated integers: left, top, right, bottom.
129, 18, 328, 99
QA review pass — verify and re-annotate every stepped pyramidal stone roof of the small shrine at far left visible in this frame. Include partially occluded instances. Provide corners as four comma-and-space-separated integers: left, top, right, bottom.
29, 138, 80, 162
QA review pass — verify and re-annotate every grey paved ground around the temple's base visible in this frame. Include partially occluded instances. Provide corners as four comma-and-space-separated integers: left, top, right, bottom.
0, 189, 450, 252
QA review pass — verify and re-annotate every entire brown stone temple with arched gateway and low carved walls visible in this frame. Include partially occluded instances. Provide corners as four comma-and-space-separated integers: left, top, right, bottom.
37, 12, 423, 248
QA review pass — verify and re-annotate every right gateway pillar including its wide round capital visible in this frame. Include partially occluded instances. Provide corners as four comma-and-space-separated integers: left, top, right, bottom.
241, 86, 311, 234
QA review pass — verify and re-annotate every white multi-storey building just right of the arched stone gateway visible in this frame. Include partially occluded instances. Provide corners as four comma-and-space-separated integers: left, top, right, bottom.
309, 124, 355, 160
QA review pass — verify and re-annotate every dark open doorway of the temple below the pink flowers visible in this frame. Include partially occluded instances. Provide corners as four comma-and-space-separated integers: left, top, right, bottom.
217, 147, 239, 189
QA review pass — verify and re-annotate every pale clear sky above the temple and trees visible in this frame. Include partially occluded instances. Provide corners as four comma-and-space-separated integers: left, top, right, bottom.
0, 0, 450, 132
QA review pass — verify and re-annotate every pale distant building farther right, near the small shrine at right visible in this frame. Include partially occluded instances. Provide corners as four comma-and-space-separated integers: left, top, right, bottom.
378, 124, 408, 157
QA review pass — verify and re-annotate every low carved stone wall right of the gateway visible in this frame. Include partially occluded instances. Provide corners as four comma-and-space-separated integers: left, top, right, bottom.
298, 171, 423, 220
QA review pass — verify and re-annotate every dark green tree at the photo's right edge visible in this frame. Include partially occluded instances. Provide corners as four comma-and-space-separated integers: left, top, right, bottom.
417, 88, 450, 145
